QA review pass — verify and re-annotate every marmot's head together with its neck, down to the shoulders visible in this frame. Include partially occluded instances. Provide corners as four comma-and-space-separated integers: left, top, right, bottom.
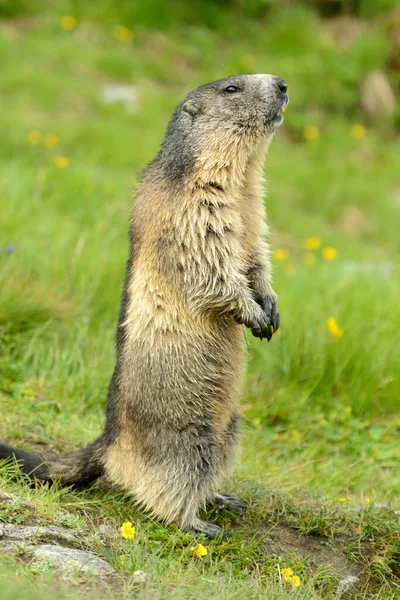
153, 75, 289, 181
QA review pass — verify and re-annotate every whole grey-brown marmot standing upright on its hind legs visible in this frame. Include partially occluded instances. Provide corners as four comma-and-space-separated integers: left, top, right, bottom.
0, 75, 288, 537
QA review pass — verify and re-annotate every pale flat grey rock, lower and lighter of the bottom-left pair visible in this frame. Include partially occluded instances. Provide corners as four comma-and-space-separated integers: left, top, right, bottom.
33, 544, 114, 575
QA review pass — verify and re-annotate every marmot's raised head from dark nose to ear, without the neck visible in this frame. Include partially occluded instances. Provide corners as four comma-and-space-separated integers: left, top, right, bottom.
183, 75, 289, 137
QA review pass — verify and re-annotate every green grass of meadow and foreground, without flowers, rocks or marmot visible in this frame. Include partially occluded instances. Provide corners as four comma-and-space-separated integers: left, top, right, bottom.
0, 1, 400, 600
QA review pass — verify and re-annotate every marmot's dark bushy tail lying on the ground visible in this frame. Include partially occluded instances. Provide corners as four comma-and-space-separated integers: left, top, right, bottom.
0, 437, 105, 487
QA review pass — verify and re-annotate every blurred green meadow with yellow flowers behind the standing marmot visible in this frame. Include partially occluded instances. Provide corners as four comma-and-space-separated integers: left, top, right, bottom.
0, 0, 400, 596
